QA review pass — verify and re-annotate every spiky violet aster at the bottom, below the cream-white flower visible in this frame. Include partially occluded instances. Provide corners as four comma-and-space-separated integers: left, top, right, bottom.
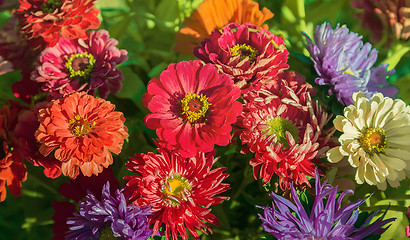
259, 169, 395, 240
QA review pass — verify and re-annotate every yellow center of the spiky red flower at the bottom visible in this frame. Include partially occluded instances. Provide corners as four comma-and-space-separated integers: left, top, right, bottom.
161, 174, 191, 206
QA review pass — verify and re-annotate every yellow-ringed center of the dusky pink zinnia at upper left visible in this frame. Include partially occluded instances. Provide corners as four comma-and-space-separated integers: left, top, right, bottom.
65, 52, 95, 79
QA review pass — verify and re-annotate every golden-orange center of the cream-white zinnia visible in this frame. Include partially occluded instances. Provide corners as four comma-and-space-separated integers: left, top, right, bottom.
359, 128, 388, 154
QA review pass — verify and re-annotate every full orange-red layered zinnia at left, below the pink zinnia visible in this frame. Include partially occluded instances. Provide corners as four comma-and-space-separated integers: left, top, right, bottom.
35, 92, 128, 178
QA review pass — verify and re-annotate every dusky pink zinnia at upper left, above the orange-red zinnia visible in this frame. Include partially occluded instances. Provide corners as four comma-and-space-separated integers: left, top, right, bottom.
32, 30, 128, 98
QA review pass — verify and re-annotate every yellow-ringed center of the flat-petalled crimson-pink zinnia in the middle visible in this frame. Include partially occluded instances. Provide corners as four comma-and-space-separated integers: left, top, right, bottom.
181, 93, 211, 123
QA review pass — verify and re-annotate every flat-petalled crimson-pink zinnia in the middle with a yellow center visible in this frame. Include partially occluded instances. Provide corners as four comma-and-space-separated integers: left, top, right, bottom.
143, 61, 242, 156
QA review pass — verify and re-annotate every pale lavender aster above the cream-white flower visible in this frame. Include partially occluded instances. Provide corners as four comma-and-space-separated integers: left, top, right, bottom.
303, 22, 398, 105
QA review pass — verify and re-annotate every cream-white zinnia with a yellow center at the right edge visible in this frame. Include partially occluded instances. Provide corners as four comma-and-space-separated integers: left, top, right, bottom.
326, 92, 410, 190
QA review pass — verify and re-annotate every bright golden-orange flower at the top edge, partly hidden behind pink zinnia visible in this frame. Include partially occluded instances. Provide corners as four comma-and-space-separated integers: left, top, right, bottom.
174, 0, 273, 54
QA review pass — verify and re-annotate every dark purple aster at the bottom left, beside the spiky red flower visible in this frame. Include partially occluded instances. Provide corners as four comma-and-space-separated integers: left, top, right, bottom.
66, 182, 153, 240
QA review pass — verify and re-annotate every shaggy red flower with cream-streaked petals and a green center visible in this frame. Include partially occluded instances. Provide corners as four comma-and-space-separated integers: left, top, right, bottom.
237, 79, 334, 189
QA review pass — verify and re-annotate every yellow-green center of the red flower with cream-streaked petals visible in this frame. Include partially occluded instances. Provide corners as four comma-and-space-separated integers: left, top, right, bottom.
265, 117, 299, 148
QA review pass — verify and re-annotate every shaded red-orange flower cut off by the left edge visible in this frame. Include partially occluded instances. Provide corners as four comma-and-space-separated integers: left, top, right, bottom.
0, 106, 27, 202
